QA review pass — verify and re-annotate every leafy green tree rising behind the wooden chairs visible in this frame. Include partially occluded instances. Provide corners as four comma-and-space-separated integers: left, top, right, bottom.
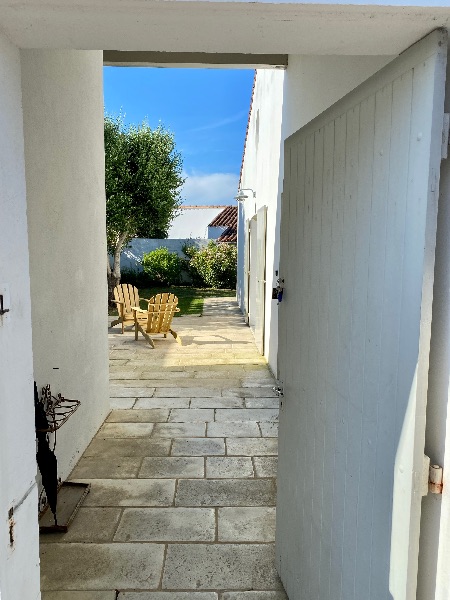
105, 115, 184, 301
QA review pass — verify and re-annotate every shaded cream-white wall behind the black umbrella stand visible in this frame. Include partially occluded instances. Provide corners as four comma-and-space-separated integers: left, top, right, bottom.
21, 50, 109, 479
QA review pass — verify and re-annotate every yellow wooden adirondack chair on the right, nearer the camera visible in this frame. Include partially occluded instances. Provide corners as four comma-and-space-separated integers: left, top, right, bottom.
133, 293, 181, 348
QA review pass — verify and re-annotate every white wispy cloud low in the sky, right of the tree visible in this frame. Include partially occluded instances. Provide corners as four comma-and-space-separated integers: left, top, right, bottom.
181, 173, 239, 205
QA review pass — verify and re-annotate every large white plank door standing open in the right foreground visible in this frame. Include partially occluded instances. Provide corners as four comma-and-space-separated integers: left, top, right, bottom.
276, 31, 447, 600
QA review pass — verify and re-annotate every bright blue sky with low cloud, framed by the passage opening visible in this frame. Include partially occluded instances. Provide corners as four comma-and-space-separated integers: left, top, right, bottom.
104, 67, 253, 204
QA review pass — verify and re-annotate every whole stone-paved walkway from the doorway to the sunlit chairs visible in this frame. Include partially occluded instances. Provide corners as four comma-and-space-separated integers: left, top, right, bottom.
41, 298, 286, 600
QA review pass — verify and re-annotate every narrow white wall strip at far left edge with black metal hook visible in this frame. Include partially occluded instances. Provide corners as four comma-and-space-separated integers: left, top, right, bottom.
0, 35, 40, 600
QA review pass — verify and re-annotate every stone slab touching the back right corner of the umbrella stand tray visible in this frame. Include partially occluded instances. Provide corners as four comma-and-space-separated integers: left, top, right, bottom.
79, 479, 175, 506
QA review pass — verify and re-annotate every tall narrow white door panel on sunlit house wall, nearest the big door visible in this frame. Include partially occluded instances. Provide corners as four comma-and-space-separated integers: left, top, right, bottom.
254, 206, 267, 354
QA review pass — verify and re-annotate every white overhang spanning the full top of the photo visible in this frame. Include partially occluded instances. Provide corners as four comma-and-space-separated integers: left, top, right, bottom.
0, 0, 450, 55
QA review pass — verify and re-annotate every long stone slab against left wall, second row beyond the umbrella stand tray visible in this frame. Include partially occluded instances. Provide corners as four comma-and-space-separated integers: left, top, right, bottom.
84, 434, 170, 458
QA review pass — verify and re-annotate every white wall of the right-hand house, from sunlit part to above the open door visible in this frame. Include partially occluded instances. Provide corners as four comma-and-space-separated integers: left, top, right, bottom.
237, 55, 390, 374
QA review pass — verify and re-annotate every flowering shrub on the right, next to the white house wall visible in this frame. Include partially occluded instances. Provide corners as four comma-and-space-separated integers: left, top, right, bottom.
189, 241, 237, 289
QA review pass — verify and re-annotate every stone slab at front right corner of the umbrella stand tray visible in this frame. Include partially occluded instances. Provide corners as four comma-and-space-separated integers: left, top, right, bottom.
41, 505, 122, 544
